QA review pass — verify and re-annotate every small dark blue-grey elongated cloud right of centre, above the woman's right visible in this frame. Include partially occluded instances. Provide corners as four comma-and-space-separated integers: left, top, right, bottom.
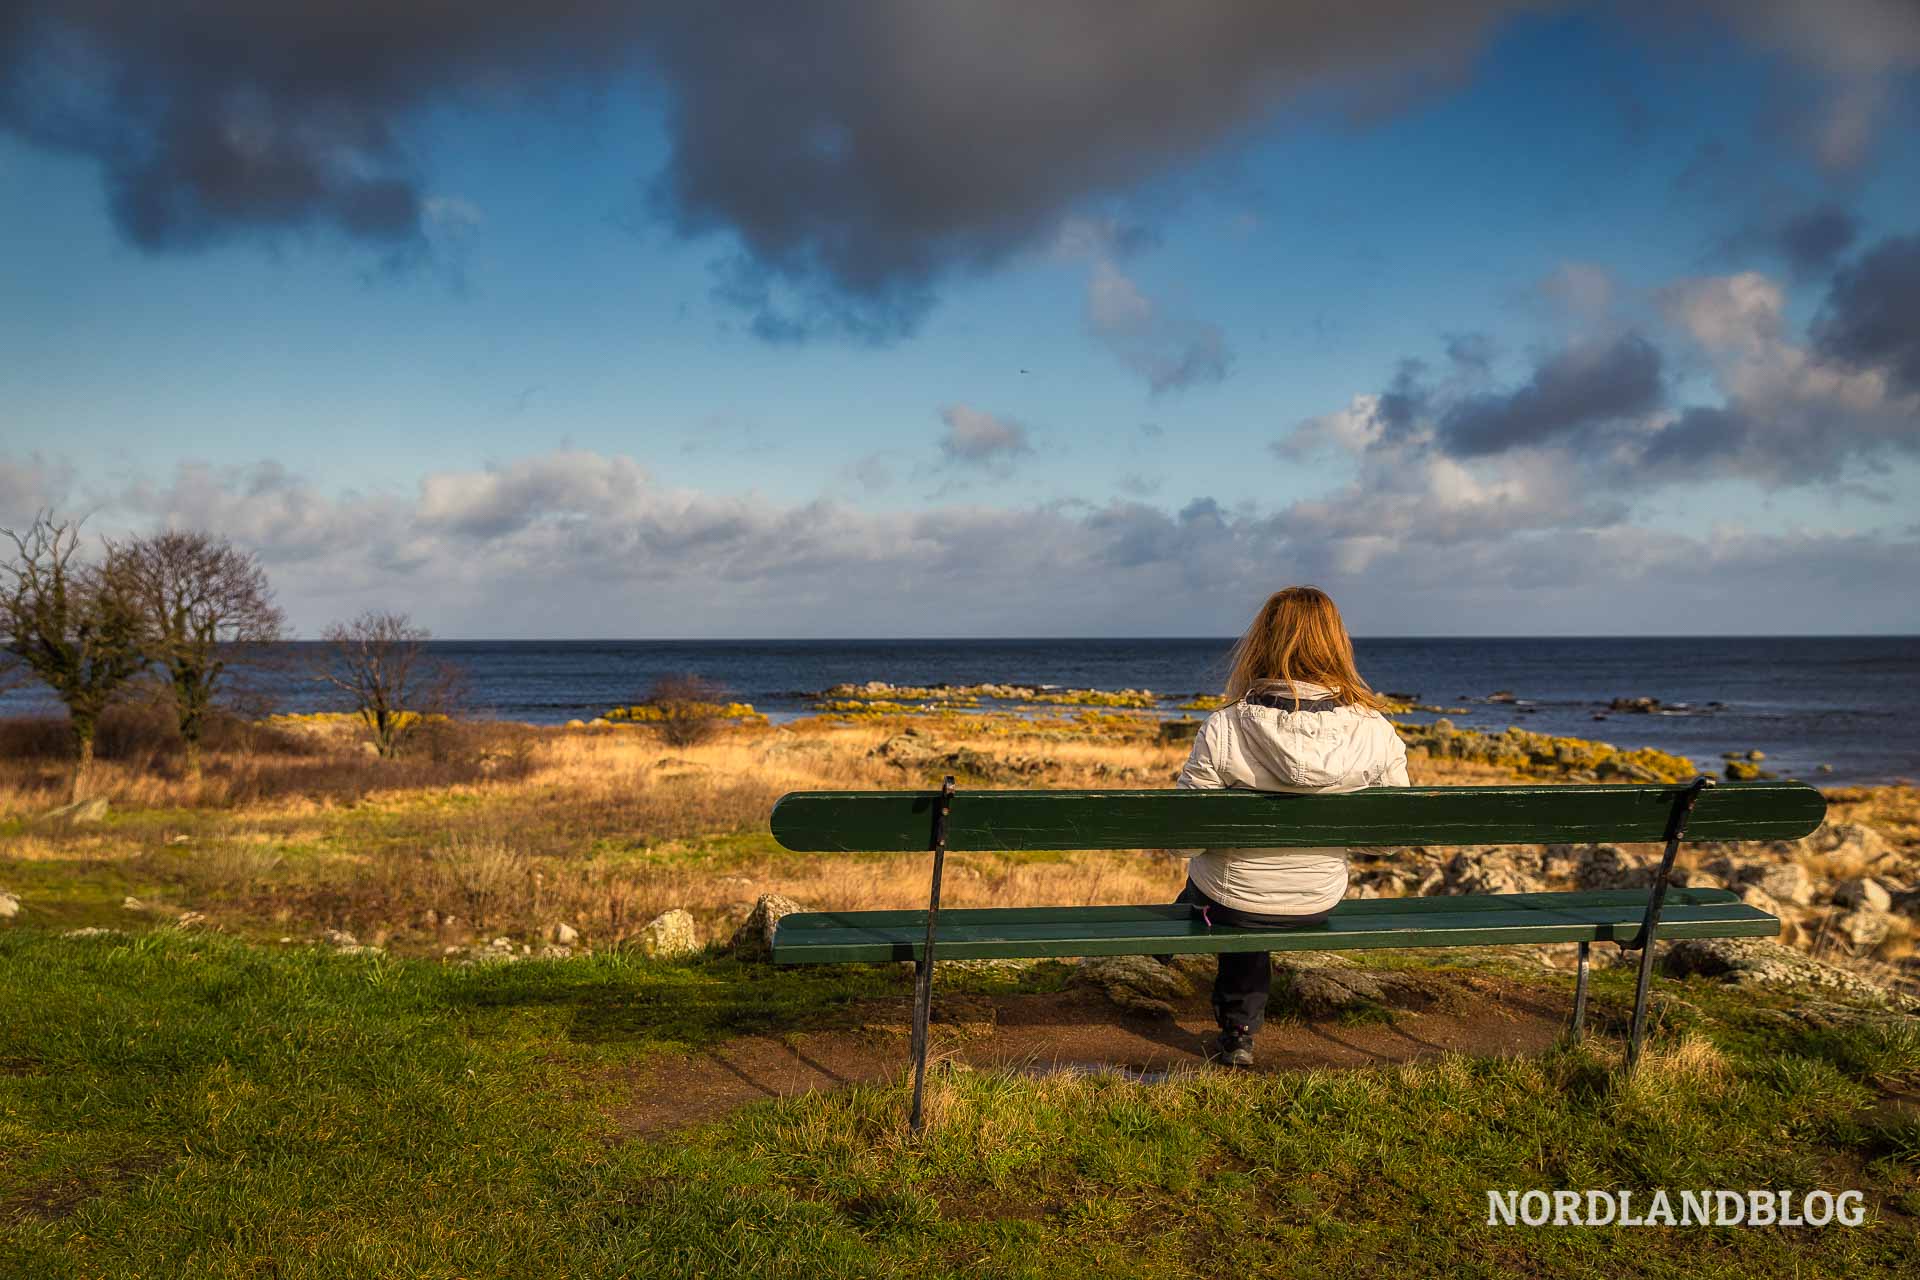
1440, 334, 1665, 457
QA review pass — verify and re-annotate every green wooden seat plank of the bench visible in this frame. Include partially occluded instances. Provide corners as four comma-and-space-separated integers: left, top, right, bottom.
774, 894, 1780, 963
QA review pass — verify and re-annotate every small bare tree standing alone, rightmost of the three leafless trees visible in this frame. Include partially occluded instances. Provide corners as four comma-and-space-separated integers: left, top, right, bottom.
319, 610, 459, 756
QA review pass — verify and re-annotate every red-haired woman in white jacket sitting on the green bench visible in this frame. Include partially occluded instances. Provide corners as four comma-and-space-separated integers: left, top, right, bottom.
1177, 587, 1407, 1067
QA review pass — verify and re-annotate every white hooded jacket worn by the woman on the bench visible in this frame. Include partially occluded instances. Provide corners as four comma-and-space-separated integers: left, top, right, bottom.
1179, 681, 1407, 915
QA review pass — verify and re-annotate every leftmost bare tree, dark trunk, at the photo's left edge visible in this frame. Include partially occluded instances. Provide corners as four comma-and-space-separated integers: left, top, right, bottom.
0, 512, 152, 800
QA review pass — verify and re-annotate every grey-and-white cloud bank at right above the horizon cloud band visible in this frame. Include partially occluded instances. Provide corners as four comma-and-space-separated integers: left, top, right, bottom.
1273, 255, 1920, 491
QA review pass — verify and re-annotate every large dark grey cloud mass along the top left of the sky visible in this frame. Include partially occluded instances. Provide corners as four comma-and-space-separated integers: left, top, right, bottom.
0, 0, 1524, 337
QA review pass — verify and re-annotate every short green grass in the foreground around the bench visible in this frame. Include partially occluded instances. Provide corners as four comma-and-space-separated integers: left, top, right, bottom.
0, 927, 1920, 1280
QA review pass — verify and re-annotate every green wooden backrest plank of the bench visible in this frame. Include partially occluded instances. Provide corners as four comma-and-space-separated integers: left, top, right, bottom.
772, 783, 1826, 852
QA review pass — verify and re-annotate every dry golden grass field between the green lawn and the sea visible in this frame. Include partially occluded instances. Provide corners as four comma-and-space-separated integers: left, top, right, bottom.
0, 706, 1920, 958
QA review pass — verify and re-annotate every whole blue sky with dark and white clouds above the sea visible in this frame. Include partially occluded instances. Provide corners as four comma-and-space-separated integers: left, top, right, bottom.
0, 0, 1920, 637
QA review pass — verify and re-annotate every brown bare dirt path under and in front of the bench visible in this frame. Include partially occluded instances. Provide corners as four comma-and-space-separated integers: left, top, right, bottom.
616, 977, 1567, 1134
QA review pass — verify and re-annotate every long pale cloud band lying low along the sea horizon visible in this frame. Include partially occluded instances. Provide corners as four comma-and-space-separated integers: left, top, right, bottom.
15, 445, 1920, 637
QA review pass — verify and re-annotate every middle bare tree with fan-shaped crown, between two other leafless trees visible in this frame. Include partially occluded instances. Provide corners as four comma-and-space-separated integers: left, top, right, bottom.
113, 530, 286, 777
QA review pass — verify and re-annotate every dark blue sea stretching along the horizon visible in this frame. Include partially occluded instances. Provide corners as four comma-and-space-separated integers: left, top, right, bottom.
0, 635, 1920, 785
